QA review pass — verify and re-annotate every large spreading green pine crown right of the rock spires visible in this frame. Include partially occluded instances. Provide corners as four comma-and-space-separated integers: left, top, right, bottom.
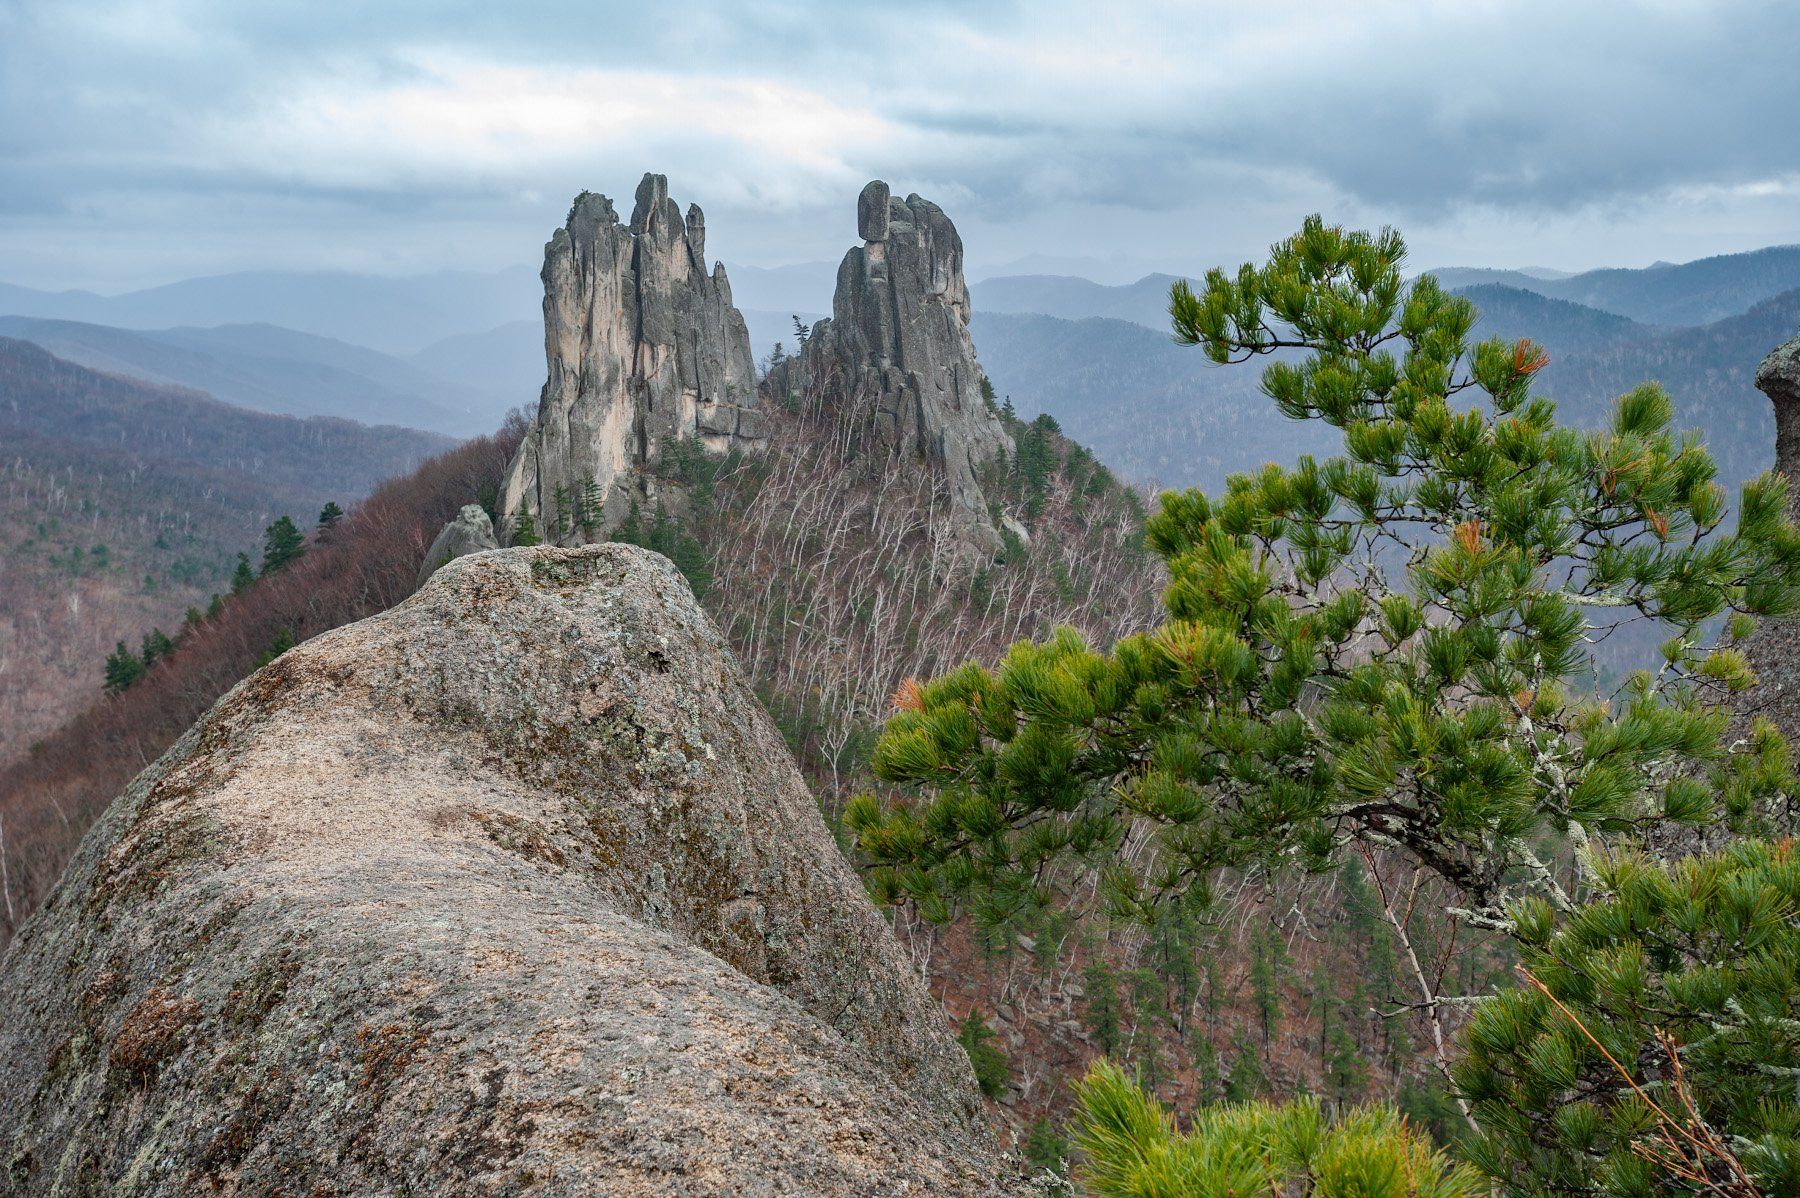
846, 218, 1800, 928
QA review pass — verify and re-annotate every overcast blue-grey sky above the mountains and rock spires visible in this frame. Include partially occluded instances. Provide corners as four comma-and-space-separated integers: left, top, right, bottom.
0, 0, 1800, 291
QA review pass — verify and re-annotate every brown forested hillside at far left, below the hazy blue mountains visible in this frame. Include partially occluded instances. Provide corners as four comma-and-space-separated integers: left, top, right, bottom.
0, 338, 450, 761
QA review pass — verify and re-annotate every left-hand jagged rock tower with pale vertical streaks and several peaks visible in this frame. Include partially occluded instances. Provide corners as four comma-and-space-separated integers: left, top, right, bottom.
502, 174, 767, 543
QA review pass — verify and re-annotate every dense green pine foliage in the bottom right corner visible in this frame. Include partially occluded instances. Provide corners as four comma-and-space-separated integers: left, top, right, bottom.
1456, 840, 1800, 1196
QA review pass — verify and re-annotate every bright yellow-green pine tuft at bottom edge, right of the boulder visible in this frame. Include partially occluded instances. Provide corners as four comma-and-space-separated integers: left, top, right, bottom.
1075, 1061, 1485, 1198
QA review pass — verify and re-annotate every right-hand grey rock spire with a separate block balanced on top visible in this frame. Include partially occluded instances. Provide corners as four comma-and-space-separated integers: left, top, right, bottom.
765, 180, 1013, 549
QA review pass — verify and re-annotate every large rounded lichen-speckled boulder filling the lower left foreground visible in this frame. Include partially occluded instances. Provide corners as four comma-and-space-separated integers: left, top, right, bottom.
0, 545, 1004, 1198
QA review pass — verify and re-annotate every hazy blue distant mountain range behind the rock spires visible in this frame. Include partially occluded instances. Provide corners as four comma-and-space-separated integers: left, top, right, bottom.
0, 237, 1800, 487
